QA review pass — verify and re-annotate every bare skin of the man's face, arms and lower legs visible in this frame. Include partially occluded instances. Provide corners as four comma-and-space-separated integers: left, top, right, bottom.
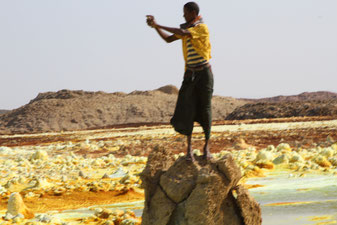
146, 8, 212, 162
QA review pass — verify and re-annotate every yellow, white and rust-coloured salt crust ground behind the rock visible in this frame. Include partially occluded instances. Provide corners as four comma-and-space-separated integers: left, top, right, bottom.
0, 117, 337, 223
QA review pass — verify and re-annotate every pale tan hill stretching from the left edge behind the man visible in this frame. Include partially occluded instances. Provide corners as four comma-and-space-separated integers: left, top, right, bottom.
0, 85, 248, 134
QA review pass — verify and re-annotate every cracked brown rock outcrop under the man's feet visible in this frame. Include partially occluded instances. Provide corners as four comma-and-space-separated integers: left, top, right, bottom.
141, 147, 262, 225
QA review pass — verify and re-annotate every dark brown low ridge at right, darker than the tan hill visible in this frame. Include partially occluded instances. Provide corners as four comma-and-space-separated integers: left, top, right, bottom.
226, 99, 337, 120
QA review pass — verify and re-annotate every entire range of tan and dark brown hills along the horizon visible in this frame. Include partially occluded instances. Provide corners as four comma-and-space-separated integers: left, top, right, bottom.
0, 88, 337, 134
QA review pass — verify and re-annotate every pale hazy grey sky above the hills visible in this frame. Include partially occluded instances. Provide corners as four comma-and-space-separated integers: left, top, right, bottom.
0, 0, 337, 109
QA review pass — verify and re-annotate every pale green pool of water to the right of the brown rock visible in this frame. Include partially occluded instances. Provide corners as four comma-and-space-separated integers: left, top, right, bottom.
247, 172, 337, 225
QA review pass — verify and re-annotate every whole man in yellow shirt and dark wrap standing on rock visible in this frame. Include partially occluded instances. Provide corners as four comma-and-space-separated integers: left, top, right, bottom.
147, 2, 213, 161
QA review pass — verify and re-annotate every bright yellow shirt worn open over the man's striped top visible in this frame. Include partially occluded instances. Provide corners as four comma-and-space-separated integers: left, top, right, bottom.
175, 23, 211, 62
